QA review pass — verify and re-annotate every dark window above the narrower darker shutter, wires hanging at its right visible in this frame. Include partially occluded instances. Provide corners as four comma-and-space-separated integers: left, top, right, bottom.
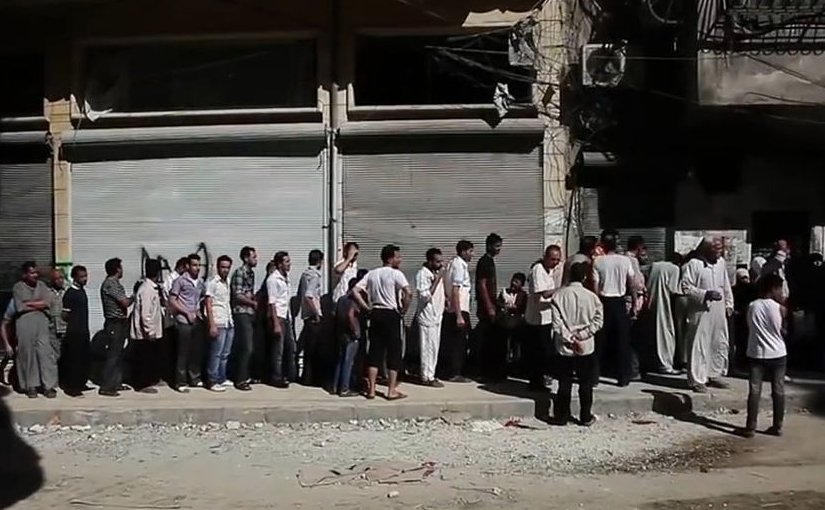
354, 31, 534, 106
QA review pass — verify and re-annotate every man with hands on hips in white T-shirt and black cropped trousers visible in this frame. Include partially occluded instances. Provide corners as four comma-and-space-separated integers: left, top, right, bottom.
352, 244, 412, 400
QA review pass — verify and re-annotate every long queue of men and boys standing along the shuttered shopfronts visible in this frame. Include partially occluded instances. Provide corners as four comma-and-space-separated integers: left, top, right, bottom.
0, 231, 800, 430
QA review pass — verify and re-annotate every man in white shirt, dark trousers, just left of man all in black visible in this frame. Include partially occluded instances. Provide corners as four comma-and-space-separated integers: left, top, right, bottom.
437, 240, 473, 383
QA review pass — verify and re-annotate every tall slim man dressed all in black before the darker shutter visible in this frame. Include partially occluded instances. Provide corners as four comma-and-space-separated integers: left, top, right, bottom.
476, 233, 507, 382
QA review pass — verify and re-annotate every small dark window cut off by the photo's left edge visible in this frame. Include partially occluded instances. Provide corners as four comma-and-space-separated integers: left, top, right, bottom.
0, 54, 45, 117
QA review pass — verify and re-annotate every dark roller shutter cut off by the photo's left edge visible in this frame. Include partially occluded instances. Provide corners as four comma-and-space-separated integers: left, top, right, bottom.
0, 161, 54, 290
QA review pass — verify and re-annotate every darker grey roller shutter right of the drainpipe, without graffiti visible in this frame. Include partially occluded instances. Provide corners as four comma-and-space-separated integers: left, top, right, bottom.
343, 150, 544, 320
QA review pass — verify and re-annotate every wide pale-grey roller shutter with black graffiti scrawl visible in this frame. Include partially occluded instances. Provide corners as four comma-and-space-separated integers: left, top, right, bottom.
72, 156, 326, 334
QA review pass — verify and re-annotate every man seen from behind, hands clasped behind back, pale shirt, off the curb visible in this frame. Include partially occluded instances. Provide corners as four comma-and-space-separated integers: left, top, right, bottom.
550, 262, 603, 427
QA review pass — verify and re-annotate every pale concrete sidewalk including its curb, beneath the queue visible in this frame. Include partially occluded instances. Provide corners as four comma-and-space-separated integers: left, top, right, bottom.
4, 377, 825, 427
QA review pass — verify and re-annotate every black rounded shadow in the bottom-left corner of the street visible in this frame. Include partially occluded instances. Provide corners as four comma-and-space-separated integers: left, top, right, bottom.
0, 389, 44, 508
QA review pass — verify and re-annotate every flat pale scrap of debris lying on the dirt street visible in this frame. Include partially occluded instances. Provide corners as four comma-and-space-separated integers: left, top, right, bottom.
297, 462, 436, 488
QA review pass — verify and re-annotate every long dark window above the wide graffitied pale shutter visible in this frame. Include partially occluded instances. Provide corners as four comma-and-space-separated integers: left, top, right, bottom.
85, 40, 317, 112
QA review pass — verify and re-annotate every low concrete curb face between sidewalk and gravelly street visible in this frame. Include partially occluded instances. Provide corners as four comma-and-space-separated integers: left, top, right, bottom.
13, 388, 815, 427
